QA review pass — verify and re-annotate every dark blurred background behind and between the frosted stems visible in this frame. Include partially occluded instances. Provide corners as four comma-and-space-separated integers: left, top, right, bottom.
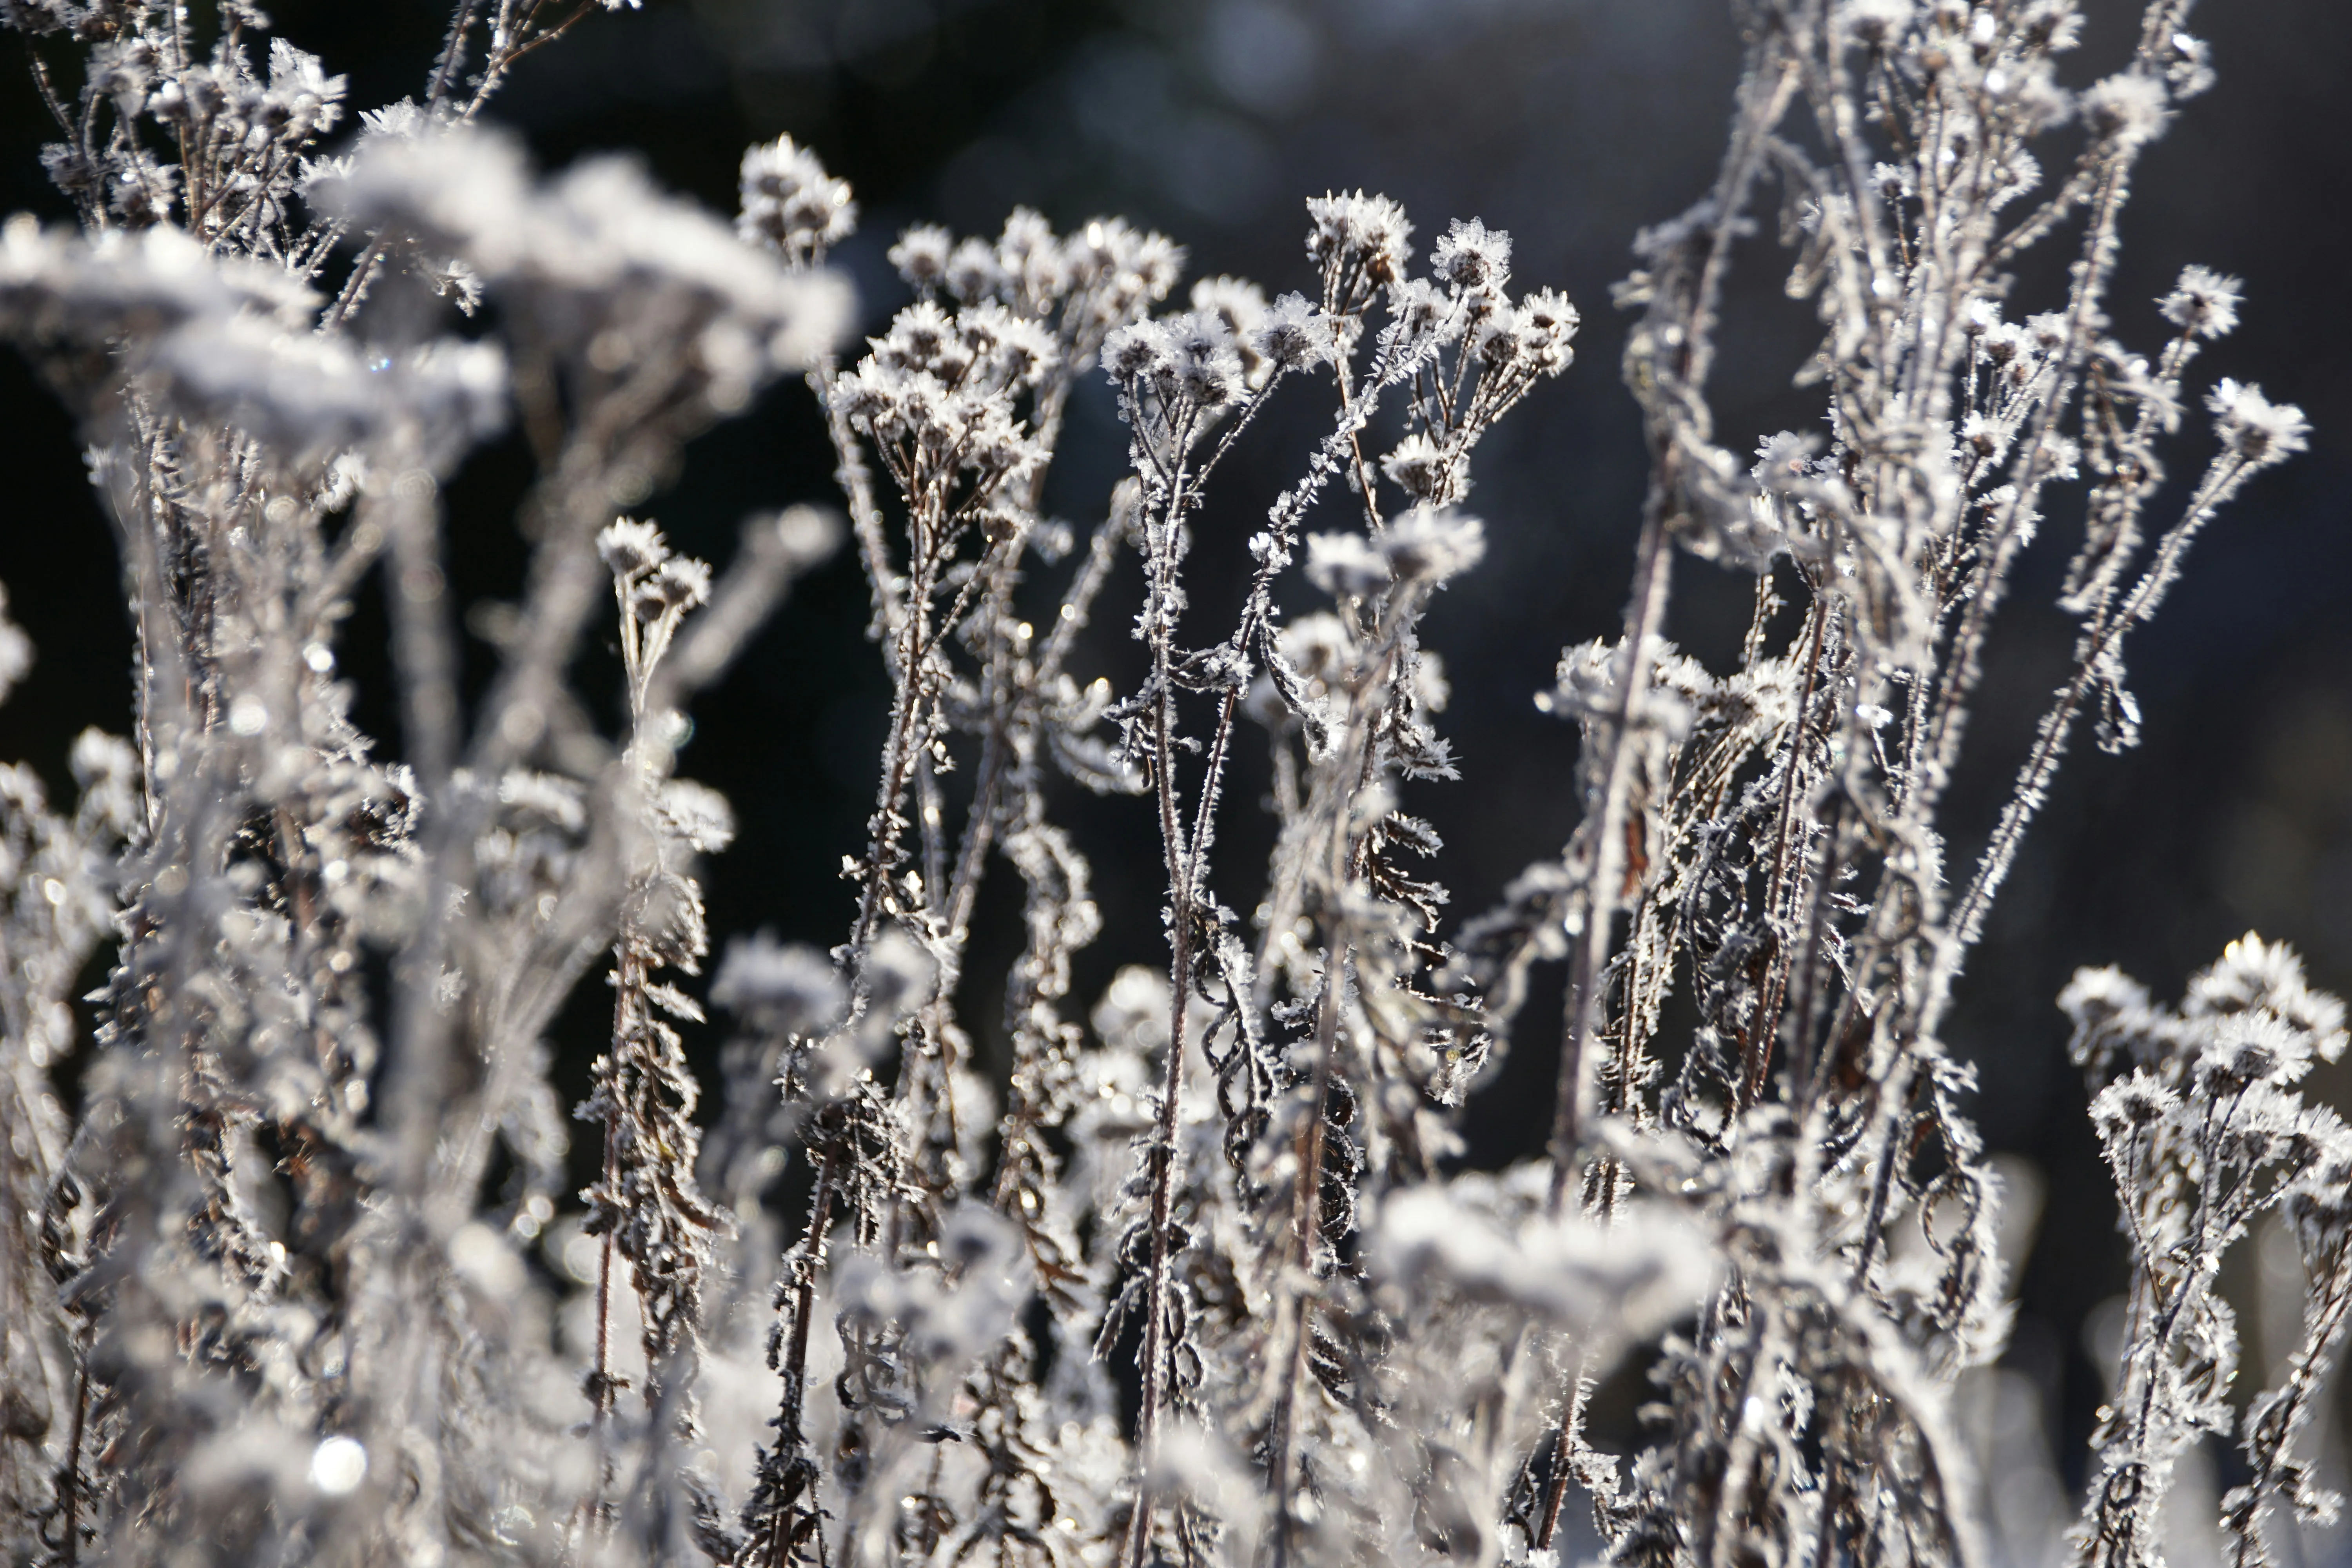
0, 0, 2352, 1514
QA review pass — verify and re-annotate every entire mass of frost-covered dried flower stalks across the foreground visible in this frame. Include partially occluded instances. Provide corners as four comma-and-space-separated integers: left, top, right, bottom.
0, 0, 2352, 1568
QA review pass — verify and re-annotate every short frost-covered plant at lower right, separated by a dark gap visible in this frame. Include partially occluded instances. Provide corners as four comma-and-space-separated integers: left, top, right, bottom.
2058, 936, 2352, 1568
